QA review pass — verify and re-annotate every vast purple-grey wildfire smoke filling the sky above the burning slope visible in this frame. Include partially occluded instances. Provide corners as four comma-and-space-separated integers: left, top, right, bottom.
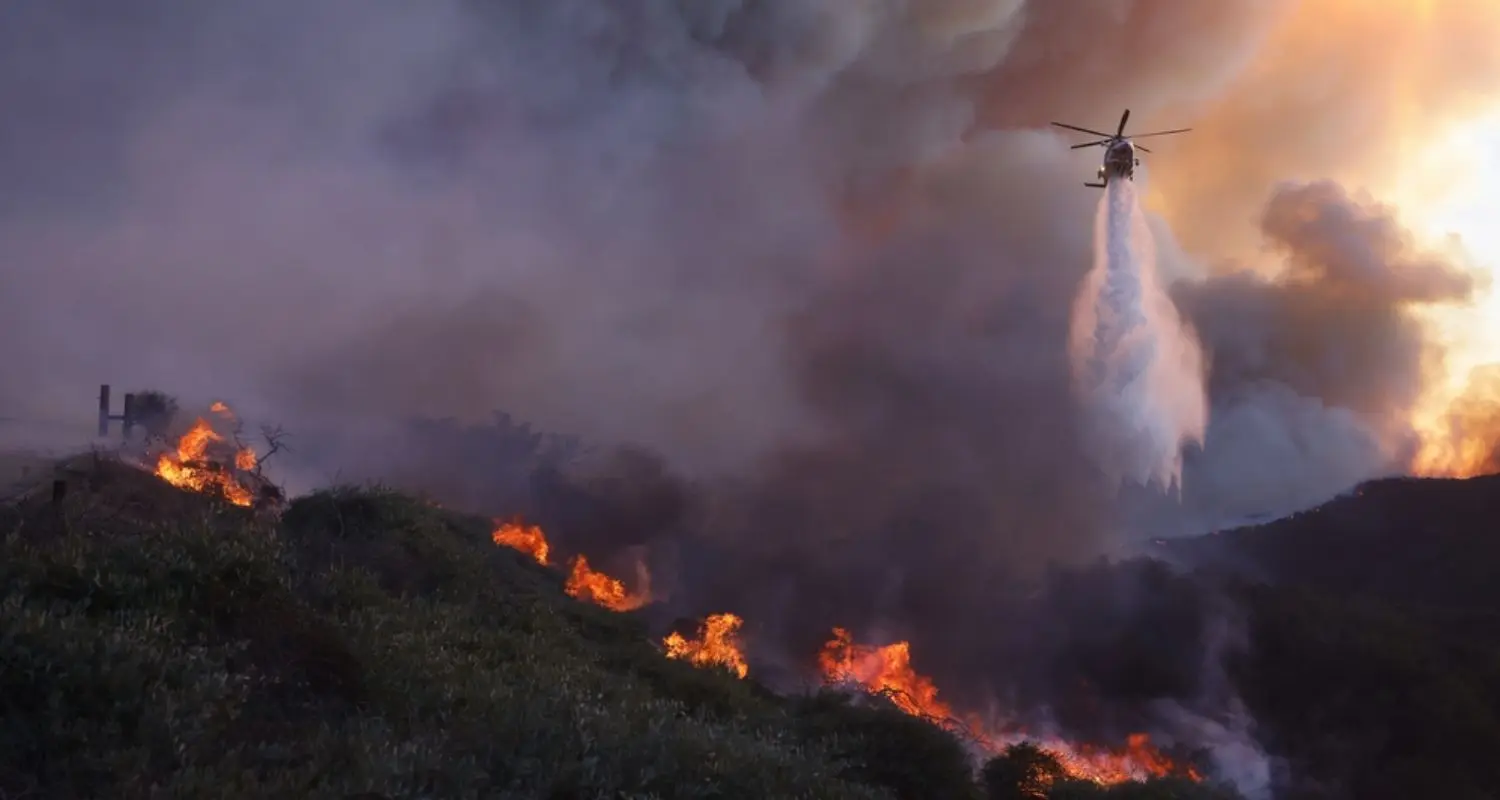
0, 0, 1494, 792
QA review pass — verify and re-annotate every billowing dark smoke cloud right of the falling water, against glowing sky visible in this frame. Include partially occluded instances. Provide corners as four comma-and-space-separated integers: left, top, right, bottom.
1128, 182, 1485, 533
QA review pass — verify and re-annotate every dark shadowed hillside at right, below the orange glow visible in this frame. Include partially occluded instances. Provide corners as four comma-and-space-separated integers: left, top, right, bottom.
1160, 476, 1500, 798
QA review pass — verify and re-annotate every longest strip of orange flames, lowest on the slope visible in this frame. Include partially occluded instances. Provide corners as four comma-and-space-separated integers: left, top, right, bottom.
818, 627, 1202, 785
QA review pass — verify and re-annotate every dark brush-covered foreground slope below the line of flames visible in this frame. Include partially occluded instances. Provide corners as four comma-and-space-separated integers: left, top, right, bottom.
0, 459, 1223, 800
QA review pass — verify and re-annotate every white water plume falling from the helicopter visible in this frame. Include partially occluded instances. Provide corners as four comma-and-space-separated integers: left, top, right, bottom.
1070, 176, 1209, 492
